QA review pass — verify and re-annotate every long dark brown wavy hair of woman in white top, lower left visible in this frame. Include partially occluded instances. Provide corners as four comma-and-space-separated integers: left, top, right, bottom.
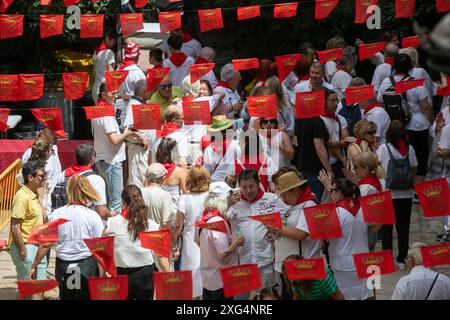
122, 185, 148, 241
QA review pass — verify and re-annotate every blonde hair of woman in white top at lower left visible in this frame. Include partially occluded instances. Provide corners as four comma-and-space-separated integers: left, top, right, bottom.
67, 175, 100, 206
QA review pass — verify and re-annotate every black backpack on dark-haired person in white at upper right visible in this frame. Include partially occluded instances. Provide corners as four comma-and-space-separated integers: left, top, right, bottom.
383, 76, 414, 124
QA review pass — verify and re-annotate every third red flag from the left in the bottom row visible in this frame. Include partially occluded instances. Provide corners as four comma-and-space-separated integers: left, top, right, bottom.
153, 270, 192, 300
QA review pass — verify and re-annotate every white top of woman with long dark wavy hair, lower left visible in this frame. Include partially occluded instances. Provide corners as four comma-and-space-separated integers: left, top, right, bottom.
106, 214, 159, 268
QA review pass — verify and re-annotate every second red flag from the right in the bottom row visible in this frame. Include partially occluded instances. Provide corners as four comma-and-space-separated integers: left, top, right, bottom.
353, 250, 396, 279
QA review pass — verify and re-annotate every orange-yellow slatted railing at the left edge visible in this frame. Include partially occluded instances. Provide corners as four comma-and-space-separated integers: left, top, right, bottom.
0, 159, 22, 230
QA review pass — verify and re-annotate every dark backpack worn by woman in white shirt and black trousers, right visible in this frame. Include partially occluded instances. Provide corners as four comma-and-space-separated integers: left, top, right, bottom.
386, 143, 414, 190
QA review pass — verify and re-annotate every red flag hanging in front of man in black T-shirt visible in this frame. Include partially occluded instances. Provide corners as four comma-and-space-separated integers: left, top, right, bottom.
295, 90, 325, 119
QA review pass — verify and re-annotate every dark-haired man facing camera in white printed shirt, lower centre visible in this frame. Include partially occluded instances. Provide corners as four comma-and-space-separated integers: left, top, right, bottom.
227, 169, 289, 300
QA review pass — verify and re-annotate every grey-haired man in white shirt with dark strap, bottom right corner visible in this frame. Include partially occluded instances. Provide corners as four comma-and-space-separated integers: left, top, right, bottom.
392, 242, 450, 300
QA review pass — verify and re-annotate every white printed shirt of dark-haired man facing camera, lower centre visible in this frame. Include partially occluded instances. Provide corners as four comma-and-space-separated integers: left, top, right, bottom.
227, 193, 289, 267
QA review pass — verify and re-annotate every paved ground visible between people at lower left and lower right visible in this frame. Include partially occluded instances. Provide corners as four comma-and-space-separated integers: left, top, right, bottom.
0, 205, 450, 300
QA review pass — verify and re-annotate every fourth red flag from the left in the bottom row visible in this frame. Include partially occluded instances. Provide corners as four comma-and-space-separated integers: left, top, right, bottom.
220, 264, 261, 298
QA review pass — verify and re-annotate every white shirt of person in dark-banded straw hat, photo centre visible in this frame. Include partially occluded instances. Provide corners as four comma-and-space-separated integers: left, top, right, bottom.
203, 140, 241, 182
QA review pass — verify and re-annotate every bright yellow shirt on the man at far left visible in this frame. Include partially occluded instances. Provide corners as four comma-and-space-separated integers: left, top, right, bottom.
10, 186, 44, 242
